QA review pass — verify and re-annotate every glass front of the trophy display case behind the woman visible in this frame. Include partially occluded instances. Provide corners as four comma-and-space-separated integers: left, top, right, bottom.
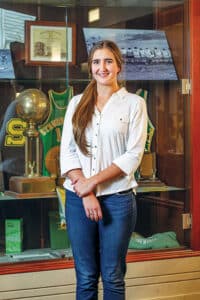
0, 0, 190, 262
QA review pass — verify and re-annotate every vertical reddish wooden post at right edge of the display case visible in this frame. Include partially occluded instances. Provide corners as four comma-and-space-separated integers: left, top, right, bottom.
189, 0, 200, 250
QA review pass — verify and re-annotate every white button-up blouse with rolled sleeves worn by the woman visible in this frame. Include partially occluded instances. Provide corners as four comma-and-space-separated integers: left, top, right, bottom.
60, 88, 147, 196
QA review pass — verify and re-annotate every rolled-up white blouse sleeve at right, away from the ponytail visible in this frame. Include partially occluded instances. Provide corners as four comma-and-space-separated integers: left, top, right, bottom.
113, 98, 147, 175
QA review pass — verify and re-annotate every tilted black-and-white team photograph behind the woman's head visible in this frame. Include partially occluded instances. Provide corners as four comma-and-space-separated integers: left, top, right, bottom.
83, 27, 178, 80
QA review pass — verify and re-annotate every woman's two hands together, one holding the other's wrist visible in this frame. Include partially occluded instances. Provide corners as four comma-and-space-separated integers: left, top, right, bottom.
72, 177, 102, 222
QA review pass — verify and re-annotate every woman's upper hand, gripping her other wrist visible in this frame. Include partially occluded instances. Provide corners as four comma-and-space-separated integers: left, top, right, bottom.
72, 177, 96, 197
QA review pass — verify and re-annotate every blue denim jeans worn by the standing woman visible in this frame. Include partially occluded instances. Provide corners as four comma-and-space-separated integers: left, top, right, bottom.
66, 190, 137, 300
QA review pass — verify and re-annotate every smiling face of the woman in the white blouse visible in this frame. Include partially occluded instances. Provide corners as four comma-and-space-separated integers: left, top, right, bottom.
91, 48, 120, 86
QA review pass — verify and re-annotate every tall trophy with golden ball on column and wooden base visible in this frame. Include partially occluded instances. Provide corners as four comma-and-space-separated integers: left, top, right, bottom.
9, 89, 56, 196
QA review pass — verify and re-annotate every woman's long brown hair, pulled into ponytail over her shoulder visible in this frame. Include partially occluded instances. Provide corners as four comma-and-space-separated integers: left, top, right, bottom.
72, 40, 123, 155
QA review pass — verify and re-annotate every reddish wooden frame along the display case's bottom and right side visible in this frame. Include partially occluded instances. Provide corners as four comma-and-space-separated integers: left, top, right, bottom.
0, 0, 200, 275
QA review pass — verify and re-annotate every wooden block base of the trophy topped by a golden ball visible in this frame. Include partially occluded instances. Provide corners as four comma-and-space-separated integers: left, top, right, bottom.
8, 176, 56, 196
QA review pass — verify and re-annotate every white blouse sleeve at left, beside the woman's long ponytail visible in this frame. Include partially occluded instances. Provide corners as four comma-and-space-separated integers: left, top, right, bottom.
60, 96, 81, 176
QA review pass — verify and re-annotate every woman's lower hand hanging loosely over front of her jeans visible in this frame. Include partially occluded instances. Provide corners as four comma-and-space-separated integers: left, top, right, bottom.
83, 193, 103, 222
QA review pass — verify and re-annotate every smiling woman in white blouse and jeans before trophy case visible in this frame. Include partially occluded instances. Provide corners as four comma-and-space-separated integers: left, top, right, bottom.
60, 40, 147, 300
